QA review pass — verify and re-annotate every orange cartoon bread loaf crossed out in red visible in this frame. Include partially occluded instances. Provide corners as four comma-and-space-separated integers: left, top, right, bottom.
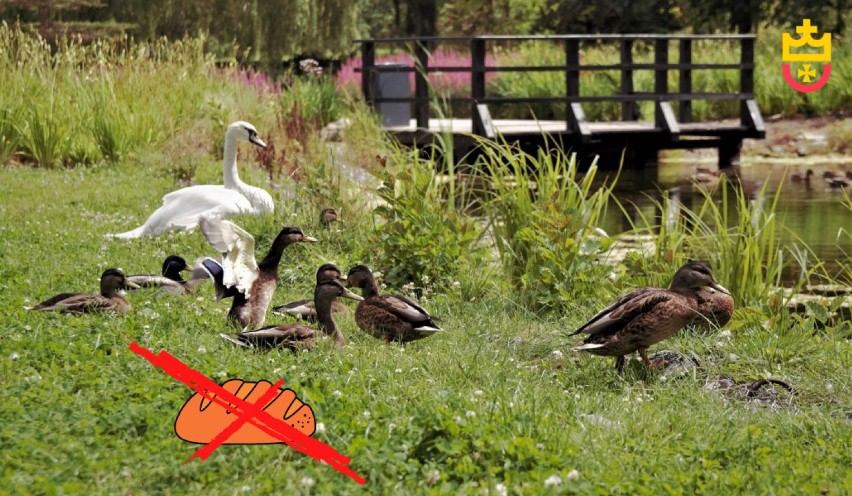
175, 379, 316, 444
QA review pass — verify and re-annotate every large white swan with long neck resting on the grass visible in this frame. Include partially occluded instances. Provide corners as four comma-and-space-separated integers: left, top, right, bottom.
107, 121, 275, 239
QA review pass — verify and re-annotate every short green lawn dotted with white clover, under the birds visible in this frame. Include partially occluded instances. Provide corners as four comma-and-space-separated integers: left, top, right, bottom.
0, 156, 852, 495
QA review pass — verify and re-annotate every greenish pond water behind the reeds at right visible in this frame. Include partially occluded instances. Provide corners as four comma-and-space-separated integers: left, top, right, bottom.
599, 158, 852, 282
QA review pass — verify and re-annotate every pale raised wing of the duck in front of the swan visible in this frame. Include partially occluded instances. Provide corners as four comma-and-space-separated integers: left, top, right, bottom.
198, 217, 259, 298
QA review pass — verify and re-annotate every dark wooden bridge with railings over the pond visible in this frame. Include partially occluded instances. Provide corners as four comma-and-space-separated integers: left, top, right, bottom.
359, 34, 765, 168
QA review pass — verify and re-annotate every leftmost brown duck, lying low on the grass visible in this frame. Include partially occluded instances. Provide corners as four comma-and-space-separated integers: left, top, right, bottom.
24, 269, 139, 314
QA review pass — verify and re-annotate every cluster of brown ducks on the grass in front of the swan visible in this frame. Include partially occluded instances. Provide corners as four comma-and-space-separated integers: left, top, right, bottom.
29, 217, 441, 348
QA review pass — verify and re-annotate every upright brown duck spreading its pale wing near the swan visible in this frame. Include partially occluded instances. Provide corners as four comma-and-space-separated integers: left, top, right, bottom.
198, 217, 316, 330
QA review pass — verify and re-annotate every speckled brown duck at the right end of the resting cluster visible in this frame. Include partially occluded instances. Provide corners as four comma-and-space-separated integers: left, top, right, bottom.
347, 265, 442, 343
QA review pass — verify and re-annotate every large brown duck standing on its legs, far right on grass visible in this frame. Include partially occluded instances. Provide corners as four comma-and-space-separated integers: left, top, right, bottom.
571, 261, 731, 373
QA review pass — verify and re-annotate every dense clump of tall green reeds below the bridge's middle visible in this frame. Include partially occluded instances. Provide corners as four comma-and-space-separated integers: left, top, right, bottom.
477, 136, 615, 311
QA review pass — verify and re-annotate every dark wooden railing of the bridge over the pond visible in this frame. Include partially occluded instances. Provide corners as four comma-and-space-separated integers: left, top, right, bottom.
352, 34, 763, 140
